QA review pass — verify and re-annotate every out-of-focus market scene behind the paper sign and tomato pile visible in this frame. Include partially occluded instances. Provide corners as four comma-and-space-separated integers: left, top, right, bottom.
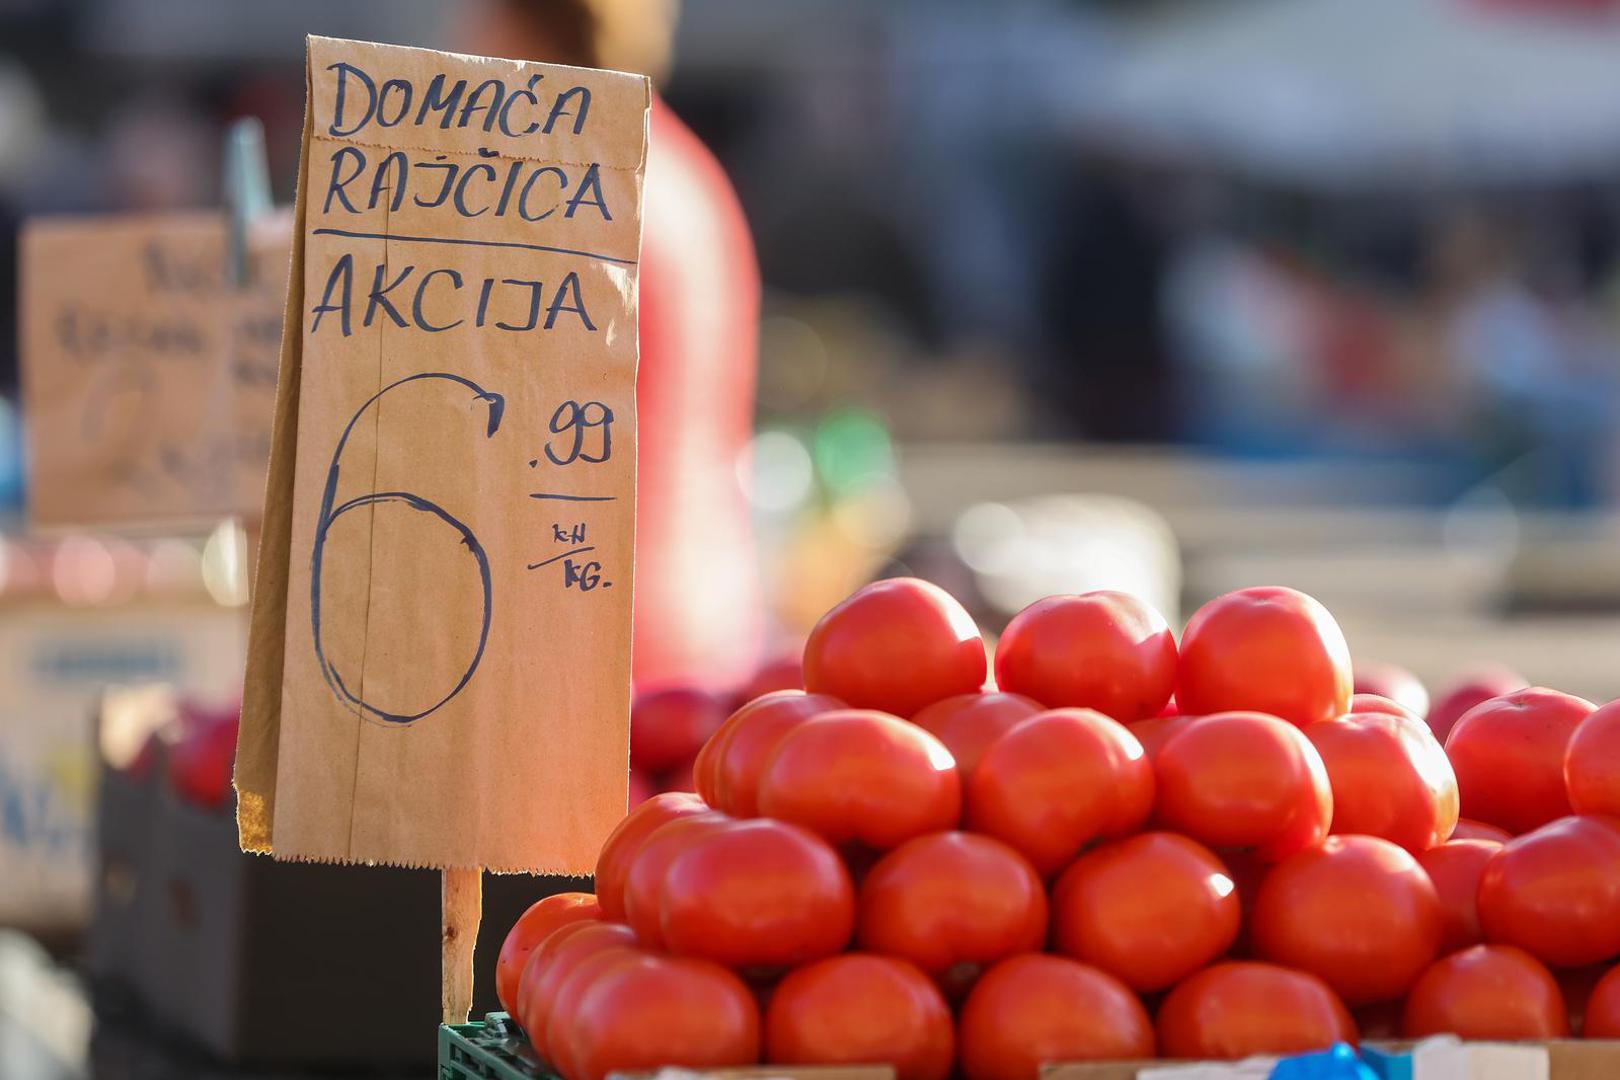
0, 0, 1620, 1078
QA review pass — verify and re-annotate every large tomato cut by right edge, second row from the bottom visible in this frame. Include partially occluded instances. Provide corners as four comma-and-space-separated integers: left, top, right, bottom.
1479, 814, 1620, 967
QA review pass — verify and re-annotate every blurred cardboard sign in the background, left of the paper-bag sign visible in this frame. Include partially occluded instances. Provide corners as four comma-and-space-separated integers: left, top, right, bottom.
21, 210, 292, 528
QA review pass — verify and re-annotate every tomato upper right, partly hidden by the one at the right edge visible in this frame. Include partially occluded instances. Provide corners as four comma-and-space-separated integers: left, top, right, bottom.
1445, 687, 1597, 836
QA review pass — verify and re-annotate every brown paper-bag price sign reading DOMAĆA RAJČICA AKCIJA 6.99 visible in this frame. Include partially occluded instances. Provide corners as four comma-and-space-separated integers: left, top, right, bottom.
237, 37, 650, 873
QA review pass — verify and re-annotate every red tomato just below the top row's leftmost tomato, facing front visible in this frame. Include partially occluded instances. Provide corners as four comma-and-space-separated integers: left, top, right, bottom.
760, 709, 962, 850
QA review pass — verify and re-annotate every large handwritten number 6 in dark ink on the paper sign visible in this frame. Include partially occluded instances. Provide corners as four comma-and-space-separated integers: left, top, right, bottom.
309, 371, 505, 724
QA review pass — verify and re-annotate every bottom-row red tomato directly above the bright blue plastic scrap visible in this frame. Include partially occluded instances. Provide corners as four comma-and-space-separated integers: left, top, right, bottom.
1158, 960, 1356, 1059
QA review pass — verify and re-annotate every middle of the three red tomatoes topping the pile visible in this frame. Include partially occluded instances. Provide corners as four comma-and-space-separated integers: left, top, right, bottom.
996, 591, 1176, 724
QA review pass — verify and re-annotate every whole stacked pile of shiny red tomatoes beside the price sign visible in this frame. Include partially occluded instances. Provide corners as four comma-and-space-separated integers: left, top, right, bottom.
497, 580, 1620, 1080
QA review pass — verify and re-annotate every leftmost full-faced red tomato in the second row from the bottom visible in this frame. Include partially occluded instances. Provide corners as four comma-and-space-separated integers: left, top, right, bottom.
659, 819, 855, 968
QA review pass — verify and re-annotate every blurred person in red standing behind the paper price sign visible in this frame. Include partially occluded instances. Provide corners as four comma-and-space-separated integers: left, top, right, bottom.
470, 0, 765, 690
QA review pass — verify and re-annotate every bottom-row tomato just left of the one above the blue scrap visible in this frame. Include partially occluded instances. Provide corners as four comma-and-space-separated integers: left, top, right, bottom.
961, 952, 1153, 1080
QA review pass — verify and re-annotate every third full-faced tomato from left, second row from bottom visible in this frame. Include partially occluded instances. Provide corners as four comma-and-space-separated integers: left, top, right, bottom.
1051, 832, 1241, 993
